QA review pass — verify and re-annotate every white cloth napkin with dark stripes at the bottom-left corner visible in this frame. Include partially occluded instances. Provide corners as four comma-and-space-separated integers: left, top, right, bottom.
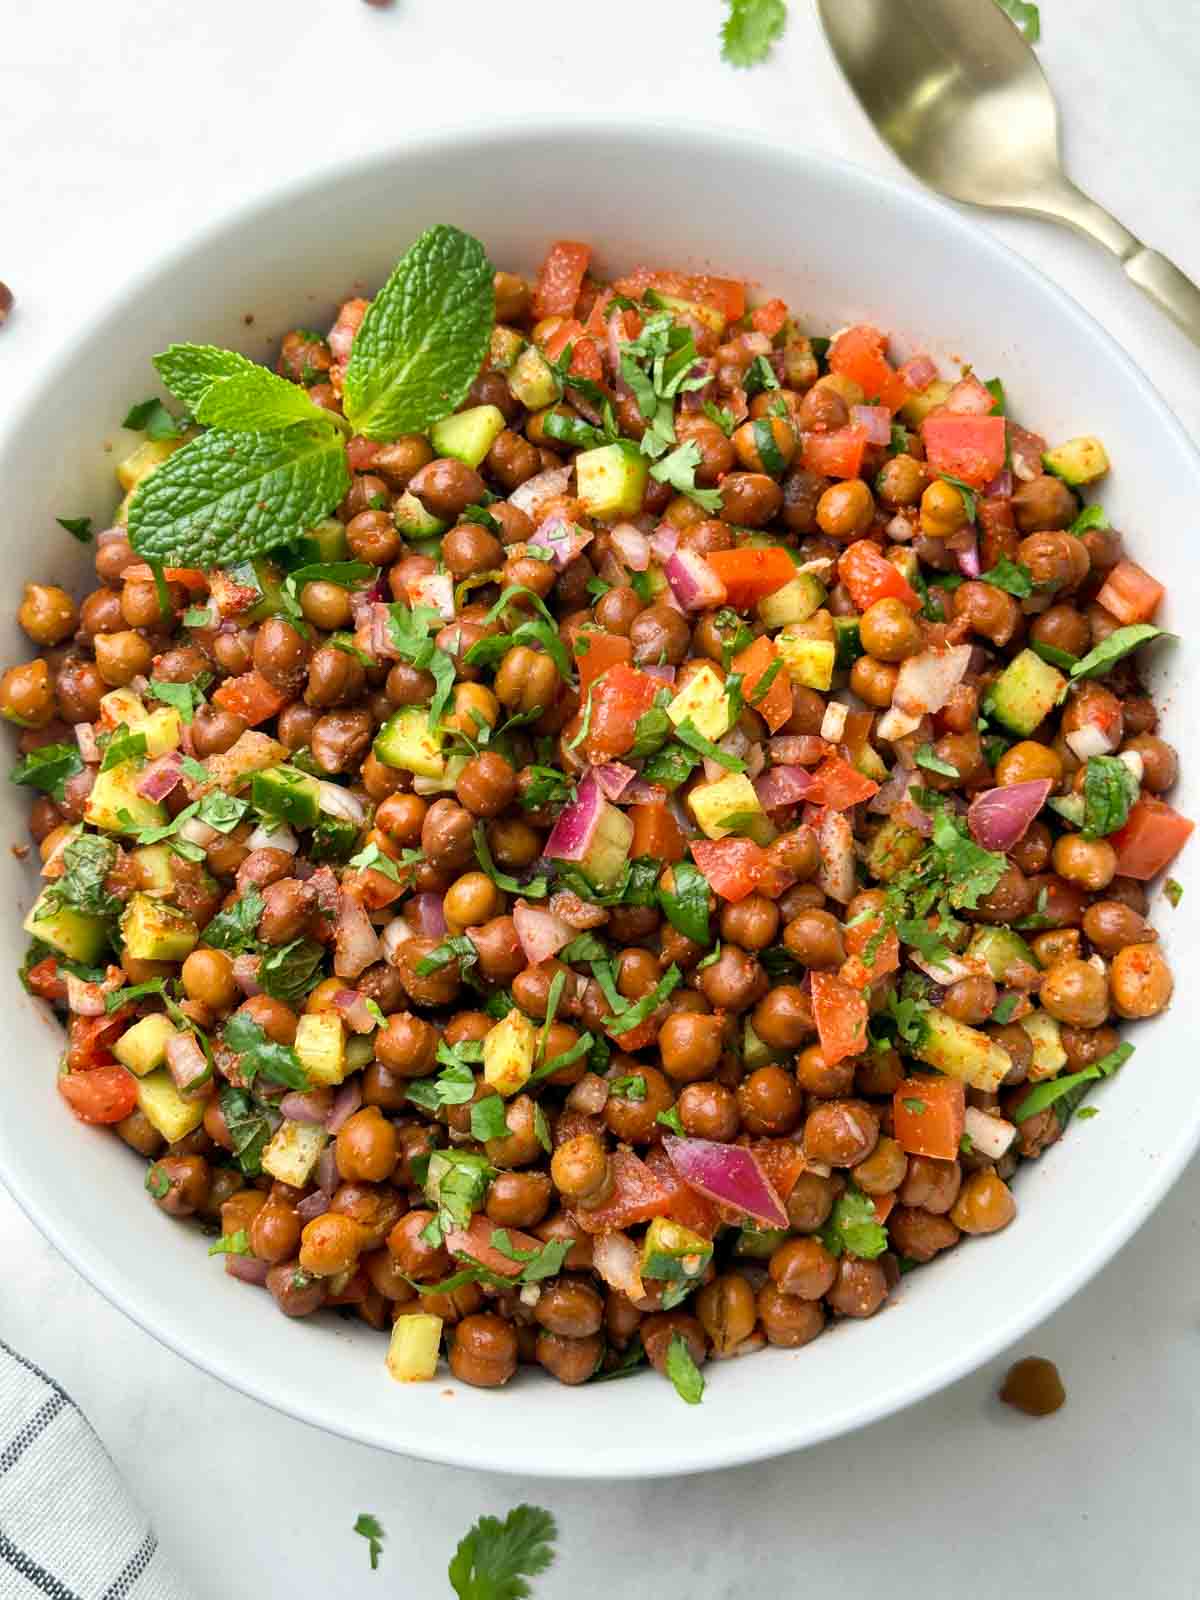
0, 1341, 187, 1600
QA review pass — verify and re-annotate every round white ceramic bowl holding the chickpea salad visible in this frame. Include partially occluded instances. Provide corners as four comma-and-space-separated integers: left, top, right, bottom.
0, 120, 1200, 1477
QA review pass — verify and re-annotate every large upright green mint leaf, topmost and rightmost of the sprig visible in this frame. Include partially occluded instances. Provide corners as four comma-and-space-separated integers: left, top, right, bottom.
346, 222, 496, 440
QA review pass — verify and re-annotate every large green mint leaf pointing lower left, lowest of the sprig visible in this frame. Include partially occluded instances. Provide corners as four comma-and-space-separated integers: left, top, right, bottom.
130, 424, 350, 566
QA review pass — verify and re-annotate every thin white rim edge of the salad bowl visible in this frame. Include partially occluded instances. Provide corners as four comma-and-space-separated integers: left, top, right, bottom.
0, 114, 1200, 1482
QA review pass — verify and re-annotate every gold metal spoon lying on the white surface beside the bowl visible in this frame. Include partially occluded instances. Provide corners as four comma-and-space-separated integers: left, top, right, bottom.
816, 0, 1200, 344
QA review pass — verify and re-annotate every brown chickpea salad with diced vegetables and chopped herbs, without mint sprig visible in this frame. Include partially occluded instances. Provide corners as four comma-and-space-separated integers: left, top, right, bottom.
9, 225, 1192, 1410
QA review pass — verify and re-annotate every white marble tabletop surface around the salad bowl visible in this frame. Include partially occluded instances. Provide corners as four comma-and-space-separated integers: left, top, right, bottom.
0, 0, 1200, 1600
